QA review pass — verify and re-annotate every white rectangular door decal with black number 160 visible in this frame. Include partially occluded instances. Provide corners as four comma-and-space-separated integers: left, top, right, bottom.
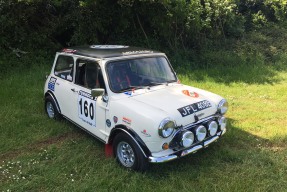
78, 91, 96, 126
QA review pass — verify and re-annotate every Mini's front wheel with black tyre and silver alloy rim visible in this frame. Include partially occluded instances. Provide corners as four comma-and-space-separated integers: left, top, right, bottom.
113, 133, 148, 172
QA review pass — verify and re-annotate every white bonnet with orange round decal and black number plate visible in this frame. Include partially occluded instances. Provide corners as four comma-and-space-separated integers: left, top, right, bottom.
130, 85, 219, 126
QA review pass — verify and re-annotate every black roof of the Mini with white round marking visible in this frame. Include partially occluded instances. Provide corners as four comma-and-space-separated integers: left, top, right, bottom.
61, 45, 162, 58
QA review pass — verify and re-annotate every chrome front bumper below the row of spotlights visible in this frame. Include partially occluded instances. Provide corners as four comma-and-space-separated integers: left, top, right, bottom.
148, 129, 226, 163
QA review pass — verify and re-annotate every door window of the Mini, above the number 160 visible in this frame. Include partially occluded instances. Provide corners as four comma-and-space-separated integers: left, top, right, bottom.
76, 59, 105, 89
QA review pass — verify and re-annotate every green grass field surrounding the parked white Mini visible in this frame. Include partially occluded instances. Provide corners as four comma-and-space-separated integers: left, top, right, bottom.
0, 57, 287, 192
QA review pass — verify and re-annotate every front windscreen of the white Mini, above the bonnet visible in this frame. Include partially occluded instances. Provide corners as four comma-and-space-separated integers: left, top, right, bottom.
107, 57, 177, 92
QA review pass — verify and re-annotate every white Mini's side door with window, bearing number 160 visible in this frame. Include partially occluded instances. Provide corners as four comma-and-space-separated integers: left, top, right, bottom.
70, 59, 108, 140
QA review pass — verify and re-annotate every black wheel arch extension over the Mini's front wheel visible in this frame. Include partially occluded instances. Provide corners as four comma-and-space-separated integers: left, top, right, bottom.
108, 125, 151, 157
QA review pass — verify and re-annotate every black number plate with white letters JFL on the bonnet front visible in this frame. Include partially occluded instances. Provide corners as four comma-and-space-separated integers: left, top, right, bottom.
177, 100, 212, 117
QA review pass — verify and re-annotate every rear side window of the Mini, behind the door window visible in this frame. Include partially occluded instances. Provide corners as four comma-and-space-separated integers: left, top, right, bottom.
54, 55, 74, 81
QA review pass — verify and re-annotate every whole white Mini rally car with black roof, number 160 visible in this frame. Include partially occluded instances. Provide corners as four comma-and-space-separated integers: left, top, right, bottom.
44, 45, 228, 171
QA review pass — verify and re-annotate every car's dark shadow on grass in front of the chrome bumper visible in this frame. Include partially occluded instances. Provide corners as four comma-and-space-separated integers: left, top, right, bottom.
147, 120, 280, 180
